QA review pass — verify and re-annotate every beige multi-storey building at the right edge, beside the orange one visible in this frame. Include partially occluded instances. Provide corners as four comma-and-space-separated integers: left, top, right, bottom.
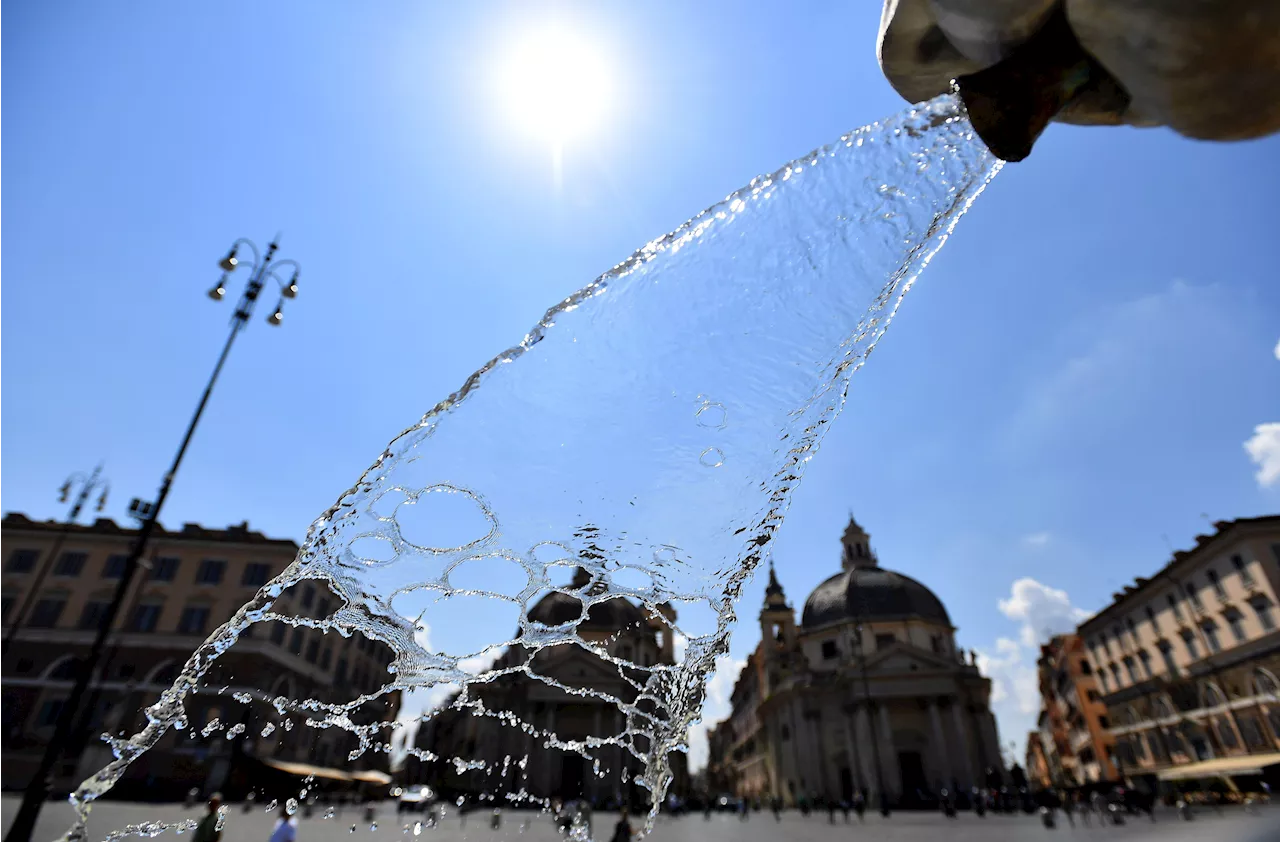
1079, 516, 1280, 786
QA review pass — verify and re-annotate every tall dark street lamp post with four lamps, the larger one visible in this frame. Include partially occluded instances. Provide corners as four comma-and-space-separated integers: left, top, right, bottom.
5, 237, 300, 842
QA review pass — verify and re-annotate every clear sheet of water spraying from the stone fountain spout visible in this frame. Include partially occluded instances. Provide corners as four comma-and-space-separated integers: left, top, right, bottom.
68, 96, 1001, 838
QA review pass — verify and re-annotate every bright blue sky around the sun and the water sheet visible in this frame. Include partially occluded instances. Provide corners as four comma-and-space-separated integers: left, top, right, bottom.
0, 3, 1280, 762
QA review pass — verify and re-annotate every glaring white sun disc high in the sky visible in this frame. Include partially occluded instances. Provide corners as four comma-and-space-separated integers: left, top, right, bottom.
499, 27, 613, 150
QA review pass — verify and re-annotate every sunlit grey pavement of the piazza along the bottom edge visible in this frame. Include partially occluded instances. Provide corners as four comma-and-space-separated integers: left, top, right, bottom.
0, 793, 1280, 842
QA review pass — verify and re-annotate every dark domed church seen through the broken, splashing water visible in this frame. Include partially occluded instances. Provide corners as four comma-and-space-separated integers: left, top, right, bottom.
404, 568, 689, 806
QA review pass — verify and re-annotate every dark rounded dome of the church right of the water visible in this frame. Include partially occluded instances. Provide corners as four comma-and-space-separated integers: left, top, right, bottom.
800, 566, 951, 628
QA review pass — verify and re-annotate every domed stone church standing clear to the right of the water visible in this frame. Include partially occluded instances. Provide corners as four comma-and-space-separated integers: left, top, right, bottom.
708, 517, 1004, 806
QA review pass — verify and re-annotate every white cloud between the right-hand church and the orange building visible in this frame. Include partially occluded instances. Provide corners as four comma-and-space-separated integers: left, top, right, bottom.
974, 577, 1088, 763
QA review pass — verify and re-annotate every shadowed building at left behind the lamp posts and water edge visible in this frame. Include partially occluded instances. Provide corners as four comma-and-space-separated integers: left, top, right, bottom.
0, 513, 398, 797
